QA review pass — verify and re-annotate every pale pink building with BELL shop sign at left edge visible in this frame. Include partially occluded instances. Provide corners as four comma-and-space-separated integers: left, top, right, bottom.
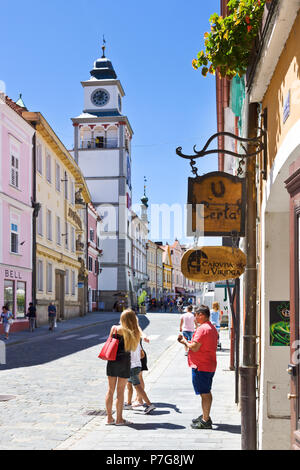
0, 97, 34, 322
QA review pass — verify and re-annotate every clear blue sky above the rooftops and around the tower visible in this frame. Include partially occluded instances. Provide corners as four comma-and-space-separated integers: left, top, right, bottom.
0, 0, 220, 242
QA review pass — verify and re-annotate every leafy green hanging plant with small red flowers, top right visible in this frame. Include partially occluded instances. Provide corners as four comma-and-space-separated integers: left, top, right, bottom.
192, 0, 271, 79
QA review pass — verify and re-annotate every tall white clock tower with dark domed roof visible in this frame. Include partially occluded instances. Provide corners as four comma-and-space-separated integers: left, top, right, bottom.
72, 46, 133, 310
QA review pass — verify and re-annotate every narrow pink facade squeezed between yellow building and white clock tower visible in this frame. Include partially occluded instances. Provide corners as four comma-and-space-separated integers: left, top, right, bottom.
87, 204, 102, 312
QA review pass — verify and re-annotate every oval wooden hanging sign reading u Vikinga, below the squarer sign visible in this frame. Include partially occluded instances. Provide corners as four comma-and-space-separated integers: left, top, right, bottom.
181, 246, 246, 282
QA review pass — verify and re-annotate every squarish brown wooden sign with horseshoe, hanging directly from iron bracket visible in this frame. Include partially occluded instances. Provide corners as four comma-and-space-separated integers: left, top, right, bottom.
187, 171, 246, 237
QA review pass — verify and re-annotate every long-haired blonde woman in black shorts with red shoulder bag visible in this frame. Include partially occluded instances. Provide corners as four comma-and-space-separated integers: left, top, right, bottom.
105, 309, 142, 426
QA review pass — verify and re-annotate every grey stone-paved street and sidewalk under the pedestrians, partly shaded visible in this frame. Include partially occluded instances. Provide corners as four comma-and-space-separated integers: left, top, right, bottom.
0, 313, 240, 450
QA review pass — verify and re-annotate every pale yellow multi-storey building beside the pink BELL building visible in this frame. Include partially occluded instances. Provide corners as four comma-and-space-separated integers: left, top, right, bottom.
24, 112, 91, 324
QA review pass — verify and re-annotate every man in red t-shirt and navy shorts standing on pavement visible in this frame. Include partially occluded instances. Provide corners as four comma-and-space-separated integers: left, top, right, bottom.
178, 305, 218, 429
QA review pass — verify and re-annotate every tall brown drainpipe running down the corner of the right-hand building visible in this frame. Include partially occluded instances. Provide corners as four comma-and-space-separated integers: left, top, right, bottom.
239, 93, 257, 450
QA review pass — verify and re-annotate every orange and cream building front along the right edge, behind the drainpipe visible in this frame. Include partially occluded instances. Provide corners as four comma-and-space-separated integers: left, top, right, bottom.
236, 1, 300, 450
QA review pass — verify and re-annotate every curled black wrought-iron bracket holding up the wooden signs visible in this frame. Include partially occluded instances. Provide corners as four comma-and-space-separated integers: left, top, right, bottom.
176, 128, 266, 176
